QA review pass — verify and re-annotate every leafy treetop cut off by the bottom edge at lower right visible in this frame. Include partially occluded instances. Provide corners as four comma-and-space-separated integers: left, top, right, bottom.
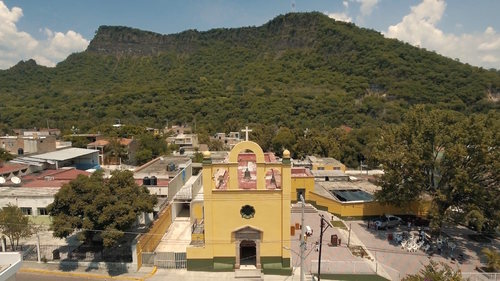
401, 260, 464, 281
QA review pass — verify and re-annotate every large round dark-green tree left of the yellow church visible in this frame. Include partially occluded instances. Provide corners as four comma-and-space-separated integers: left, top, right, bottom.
47, 168, 157, 247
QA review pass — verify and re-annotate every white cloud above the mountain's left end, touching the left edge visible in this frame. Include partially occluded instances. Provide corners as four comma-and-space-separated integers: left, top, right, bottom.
0, 1, 89, 69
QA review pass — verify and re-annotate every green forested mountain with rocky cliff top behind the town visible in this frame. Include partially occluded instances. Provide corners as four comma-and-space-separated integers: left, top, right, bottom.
0, 13, 500, 162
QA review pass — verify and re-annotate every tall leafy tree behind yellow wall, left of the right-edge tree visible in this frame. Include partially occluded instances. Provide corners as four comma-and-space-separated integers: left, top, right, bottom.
375, 106, 460, 206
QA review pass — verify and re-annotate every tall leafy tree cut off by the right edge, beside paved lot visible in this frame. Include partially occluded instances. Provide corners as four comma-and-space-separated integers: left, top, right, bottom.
434, 114, 500, 231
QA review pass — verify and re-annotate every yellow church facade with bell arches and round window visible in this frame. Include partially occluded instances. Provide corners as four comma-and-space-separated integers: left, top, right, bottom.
187, 141, 291, 274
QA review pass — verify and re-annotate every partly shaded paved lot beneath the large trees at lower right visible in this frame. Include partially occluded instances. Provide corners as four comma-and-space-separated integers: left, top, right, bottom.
349, 221, 500, 277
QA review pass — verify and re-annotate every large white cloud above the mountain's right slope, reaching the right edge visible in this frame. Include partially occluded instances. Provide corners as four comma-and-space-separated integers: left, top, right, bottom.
385, 0, 500, 69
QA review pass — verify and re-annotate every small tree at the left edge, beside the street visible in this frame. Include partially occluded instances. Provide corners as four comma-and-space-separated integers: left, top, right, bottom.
0, 204, 32, 250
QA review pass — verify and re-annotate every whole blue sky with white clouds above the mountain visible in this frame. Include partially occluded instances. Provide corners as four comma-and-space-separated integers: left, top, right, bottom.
0, 0, 500, 69
